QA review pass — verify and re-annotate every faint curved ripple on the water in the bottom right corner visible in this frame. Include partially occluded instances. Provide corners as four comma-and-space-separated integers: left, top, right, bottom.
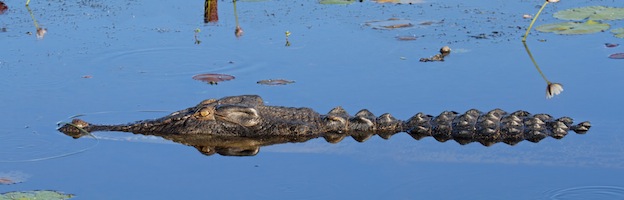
546, 186, 624, 200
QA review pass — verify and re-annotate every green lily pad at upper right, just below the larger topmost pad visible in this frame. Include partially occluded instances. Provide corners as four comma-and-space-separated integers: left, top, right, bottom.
535, 20, 611, 35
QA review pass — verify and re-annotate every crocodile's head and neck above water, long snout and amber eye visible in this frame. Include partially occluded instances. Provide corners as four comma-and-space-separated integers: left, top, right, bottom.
59, 95, 321, 138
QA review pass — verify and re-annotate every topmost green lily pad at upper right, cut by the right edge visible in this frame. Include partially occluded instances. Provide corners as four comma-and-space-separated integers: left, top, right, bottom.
553, 6, 624, 20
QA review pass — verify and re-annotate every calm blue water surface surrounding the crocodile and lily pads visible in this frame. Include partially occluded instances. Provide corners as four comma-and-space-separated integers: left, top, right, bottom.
0, 0, 624, 199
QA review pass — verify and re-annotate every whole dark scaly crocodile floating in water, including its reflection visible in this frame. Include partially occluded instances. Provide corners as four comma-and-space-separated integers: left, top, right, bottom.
58, 95, 591, 156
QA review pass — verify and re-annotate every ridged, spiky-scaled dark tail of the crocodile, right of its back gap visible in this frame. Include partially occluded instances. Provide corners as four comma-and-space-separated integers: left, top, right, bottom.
405, 109, 591, 146
